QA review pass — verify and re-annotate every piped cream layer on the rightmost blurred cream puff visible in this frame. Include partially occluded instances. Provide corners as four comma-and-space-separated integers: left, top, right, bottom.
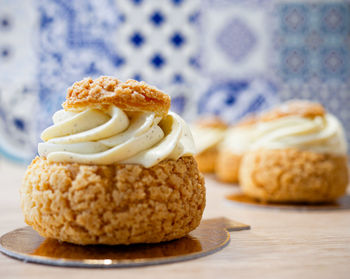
251, 114, 347, 155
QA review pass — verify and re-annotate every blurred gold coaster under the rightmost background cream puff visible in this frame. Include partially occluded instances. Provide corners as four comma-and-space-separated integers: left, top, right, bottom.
226, 193, 350, 210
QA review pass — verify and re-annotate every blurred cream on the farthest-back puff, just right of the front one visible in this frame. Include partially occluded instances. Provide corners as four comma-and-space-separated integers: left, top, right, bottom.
191, 126, 225, 154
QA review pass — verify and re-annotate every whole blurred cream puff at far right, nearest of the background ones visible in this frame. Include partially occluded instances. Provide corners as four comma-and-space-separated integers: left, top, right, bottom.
239, 100, 348, 203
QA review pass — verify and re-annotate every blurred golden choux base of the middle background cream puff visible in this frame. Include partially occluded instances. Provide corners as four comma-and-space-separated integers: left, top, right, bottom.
215, 149, 242, 183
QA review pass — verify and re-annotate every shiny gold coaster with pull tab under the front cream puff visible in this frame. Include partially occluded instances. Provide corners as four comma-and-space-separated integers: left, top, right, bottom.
0, 218, 249, 267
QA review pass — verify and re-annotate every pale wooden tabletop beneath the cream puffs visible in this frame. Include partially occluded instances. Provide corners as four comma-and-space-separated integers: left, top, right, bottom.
0, 161, 350, 279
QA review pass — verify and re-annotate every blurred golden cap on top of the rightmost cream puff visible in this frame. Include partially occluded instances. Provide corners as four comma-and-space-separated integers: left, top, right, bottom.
259, 100, 326, 121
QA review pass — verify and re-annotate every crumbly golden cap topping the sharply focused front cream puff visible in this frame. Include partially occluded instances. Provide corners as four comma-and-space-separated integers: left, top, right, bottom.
62, 76, 170, 115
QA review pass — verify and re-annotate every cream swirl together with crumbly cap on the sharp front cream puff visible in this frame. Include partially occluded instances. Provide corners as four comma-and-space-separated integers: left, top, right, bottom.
38, 77, 195, 168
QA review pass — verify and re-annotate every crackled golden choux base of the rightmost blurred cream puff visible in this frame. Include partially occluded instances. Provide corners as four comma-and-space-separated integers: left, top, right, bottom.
239, 149, 348, 203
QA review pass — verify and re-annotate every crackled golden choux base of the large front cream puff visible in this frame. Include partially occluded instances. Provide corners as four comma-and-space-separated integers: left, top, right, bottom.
21, 156, 205, 244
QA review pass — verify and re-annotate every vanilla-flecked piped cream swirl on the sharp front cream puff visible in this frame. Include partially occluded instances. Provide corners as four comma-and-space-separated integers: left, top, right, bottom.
38, 106, 195, 167
